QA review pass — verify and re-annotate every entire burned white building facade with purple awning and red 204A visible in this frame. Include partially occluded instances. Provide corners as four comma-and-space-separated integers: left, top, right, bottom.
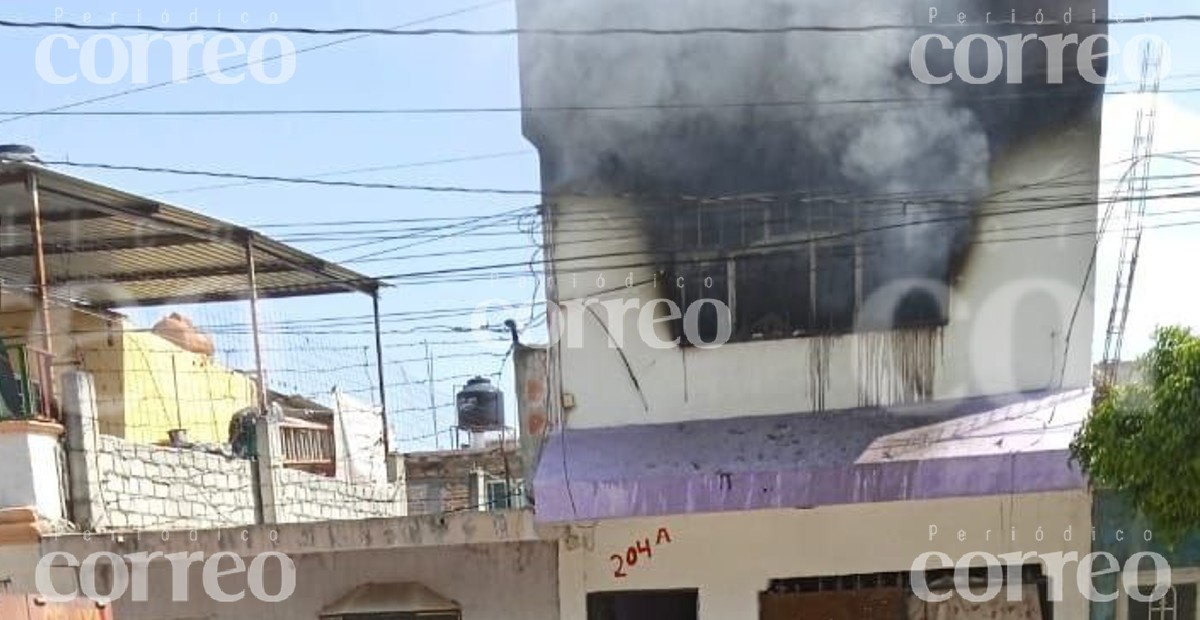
518, 0, 1100, 620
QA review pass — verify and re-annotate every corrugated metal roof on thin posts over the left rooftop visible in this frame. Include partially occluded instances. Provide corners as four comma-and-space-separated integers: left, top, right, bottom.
0, 162, 382, 307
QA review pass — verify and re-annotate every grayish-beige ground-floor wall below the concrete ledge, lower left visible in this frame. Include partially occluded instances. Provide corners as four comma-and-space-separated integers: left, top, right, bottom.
106, 542, 558, 620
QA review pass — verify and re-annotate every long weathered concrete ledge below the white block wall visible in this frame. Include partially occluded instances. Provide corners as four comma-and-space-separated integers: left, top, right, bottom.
41, 511, 557, 558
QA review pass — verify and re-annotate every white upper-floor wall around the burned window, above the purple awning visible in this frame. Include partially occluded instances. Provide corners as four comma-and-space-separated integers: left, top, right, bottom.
551, 126, 1098, 428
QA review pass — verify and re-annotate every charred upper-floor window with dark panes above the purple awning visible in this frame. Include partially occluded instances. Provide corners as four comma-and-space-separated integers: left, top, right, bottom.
668, 200, 948, 342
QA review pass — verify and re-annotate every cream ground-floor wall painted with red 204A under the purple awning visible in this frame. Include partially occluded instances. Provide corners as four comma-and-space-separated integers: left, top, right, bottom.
558, 492, 1091, 620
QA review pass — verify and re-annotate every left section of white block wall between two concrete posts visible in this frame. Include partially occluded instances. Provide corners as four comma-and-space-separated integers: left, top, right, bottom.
95, 435, 257, 529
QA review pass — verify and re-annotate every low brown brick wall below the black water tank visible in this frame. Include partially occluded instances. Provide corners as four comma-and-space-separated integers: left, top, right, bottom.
398, 446, 523, 514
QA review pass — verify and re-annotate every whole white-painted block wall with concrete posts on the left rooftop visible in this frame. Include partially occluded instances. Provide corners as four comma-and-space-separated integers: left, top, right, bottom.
64, 372, 408, 531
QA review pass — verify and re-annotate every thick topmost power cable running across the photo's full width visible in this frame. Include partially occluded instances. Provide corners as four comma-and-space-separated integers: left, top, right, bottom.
0, 14, 1200, 37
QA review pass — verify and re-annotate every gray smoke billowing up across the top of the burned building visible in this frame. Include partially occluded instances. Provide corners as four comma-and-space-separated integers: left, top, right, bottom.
518, 0, 1103, 311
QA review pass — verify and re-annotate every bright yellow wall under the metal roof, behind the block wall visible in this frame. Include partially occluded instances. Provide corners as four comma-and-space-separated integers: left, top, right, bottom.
122, 330, 254, 443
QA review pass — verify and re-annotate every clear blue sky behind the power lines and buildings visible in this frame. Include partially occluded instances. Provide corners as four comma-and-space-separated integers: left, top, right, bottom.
0, 0, 1200, 449
